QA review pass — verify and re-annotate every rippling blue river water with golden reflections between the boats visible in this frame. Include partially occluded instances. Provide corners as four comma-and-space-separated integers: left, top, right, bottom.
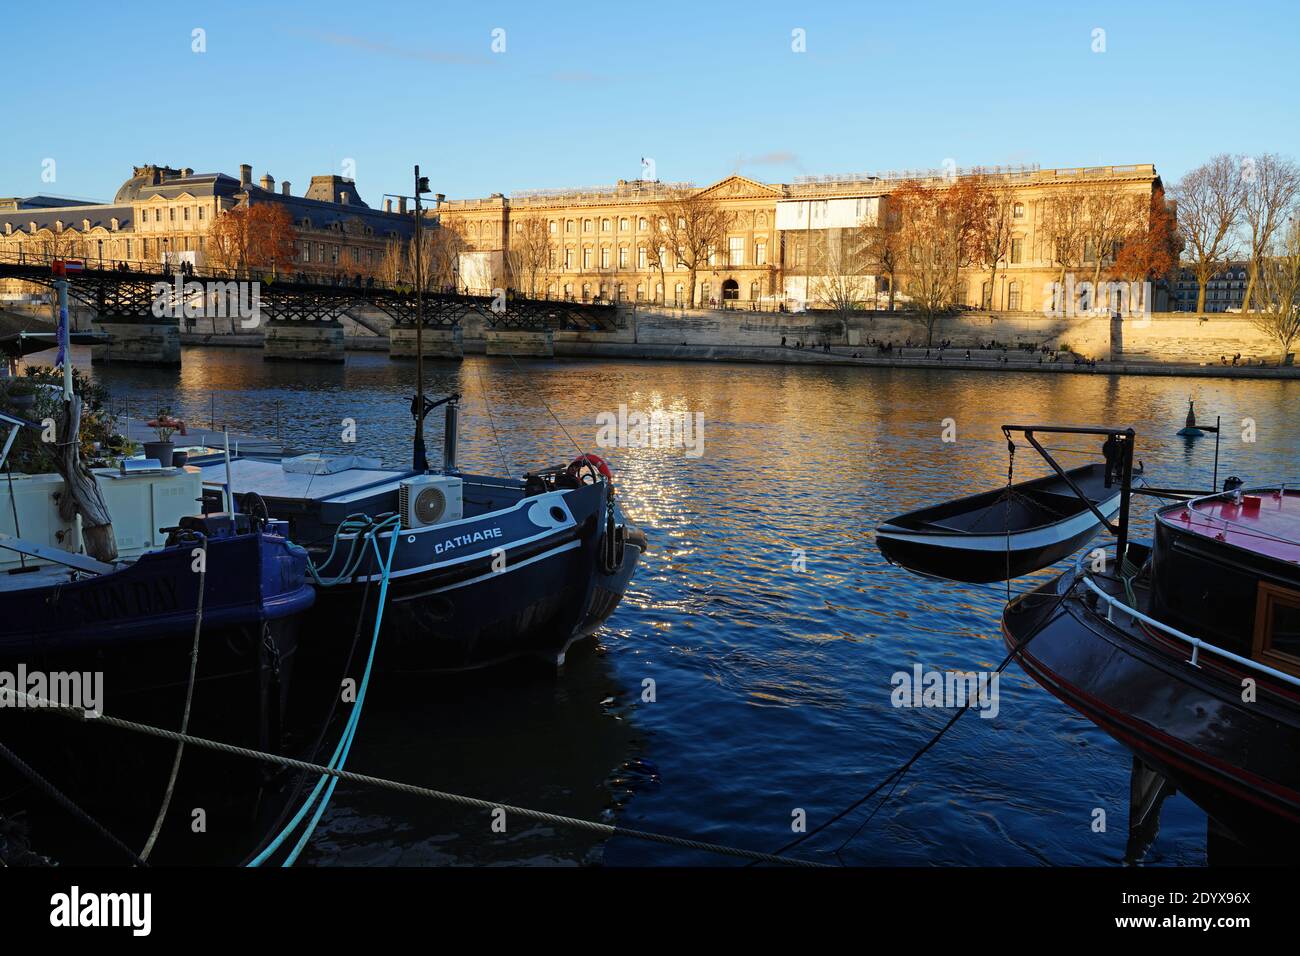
58, 349, 1300, 865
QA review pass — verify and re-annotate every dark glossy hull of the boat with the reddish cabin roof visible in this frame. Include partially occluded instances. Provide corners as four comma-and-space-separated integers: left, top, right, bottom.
1002, 575, 1300, 843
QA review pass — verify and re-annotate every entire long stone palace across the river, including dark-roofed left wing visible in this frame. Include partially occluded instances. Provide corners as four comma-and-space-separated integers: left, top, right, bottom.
0, 164, 1161, 311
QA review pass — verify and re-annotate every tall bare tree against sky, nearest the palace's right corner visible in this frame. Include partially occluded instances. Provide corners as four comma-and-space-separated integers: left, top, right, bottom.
1171, 153, 1244, 312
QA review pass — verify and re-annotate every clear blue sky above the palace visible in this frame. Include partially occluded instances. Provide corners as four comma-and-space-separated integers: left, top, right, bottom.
0, 0, 1300, 206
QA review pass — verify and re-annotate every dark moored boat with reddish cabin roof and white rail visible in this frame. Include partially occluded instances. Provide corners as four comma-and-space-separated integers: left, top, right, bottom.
1002, 481, 1300, 842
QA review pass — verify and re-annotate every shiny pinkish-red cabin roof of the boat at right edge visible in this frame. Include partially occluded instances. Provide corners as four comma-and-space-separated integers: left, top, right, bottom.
1161, 492, 1300, 564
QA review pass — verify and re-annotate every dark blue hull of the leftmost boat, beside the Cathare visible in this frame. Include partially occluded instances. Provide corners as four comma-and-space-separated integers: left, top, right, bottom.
0, 535, 315, 832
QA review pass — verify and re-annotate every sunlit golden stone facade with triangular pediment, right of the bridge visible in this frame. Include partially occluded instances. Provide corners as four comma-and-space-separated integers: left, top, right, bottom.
430, 164, 1161, 312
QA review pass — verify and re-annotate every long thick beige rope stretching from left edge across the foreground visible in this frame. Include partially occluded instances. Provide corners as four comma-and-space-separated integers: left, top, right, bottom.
0, 687, 828, 868
